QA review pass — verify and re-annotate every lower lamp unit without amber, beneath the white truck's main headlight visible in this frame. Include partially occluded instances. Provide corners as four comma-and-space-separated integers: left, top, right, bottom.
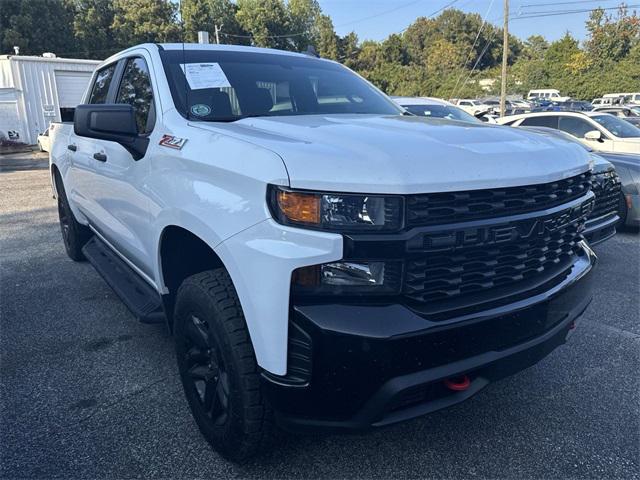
291, 261, 402, 295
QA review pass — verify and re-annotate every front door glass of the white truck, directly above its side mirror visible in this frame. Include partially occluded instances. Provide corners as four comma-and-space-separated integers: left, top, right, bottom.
116, 57, 153, 134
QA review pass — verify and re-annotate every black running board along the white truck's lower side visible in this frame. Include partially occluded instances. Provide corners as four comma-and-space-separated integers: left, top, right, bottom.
82, 236, 165, 323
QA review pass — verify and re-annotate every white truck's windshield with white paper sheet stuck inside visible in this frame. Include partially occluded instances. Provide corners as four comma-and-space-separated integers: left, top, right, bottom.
160, 50, 402, 122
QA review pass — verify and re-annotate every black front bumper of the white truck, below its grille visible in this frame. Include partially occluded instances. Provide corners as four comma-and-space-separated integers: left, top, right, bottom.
263, 249, 595, 431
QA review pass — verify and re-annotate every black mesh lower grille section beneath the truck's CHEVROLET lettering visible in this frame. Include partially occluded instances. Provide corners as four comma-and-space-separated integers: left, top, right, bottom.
403, 221, 584, 304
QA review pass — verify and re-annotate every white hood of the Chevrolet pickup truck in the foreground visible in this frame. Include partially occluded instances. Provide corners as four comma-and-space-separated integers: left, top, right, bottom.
194, 115, 590, 194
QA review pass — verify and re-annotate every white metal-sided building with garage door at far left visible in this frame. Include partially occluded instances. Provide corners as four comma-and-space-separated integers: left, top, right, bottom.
0, 54, 100, 144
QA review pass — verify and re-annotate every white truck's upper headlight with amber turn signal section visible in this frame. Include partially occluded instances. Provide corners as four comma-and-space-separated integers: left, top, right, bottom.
268, 186, 403, 232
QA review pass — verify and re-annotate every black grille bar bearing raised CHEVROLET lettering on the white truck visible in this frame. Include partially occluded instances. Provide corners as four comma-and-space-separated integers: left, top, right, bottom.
418, 198, 594, 251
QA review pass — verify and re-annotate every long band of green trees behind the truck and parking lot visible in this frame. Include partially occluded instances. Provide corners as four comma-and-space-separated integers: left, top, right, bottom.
0, 0, 640, 99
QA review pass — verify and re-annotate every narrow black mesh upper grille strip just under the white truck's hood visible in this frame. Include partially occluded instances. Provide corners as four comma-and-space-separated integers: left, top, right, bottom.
406, 172, 591, 227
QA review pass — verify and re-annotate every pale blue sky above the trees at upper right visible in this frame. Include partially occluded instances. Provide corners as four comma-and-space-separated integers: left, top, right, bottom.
319, 0, 628, 41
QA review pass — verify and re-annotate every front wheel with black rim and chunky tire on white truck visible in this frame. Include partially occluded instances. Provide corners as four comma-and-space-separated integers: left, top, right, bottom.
174, 268, 272, 462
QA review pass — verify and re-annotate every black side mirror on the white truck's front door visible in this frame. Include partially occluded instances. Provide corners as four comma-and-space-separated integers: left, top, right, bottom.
73, 104, 149, 160
